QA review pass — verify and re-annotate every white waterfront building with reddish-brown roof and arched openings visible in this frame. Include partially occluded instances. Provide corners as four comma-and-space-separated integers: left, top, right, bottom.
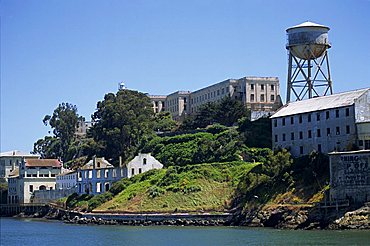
8, 159, 62, 204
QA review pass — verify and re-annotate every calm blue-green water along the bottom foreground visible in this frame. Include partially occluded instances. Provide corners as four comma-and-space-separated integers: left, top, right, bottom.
0, 218, 370, 246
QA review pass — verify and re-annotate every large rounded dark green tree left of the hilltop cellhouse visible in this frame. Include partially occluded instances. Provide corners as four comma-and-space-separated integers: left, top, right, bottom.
91, 90, 153, 160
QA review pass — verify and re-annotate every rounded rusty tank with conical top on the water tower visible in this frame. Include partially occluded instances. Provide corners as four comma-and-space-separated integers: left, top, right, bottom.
286, 22, 330, 60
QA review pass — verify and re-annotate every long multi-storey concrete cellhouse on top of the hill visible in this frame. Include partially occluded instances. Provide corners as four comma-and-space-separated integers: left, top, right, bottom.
149, 77, 282, 120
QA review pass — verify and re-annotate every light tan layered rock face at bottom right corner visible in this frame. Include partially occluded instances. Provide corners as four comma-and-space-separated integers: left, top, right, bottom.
329, 204, 370, 229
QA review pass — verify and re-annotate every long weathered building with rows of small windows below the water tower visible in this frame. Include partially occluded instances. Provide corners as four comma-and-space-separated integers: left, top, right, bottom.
271, 88, 370, 156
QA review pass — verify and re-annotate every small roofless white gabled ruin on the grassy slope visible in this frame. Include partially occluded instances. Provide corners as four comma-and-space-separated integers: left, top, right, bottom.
126, 153, 163, 178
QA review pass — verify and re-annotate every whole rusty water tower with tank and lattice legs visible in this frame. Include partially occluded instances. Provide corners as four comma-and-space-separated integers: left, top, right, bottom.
286, 22, 333, 103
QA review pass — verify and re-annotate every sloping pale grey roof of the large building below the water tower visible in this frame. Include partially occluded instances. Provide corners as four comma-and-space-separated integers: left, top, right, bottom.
271, 88, 370, 119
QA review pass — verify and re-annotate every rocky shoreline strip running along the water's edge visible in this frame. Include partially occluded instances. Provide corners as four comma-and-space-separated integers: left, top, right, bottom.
10, 203, 370, 230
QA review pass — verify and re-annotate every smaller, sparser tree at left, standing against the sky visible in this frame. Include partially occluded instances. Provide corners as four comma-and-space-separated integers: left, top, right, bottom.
33, 103, 84, 162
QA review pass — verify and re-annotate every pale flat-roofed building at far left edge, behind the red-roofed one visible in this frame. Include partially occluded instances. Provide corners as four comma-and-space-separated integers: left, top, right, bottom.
0, 150, 40, 179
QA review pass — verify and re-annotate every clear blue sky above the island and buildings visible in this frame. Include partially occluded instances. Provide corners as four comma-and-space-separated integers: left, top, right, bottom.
0, 0, 370, 152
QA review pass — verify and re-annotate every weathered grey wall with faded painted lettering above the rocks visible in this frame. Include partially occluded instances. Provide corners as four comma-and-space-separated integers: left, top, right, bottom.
329, 150, 370, 204
